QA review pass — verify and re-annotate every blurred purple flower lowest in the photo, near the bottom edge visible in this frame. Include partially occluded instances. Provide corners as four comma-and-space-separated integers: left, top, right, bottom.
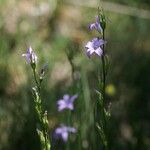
55, 126, 76, 142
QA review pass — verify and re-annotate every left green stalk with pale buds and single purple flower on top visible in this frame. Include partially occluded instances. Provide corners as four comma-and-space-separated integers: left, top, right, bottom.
22, 46, 51, 150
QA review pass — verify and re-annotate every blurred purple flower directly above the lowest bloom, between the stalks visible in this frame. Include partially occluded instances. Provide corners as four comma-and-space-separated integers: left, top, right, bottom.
57, 94, 78, 111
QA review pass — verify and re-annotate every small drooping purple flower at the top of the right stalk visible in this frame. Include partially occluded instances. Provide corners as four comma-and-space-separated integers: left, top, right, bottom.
89, 16, 102, 32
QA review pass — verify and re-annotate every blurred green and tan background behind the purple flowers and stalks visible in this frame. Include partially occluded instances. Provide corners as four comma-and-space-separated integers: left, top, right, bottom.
0, 0, 150, 150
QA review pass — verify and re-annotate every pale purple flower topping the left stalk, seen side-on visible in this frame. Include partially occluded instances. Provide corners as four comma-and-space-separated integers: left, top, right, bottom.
22, 46, 37, 64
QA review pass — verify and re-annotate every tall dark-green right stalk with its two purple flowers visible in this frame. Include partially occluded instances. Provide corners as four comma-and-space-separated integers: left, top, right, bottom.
85, 8, 109, 150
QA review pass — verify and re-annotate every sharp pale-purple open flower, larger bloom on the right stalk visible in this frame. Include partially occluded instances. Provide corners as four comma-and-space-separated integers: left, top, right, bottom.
85, 38, 106, 58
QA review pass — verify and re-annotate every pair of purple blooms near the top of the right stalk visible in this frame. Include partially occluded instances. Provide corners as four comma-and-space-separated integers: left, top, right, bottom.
85, 16, 106, 58
